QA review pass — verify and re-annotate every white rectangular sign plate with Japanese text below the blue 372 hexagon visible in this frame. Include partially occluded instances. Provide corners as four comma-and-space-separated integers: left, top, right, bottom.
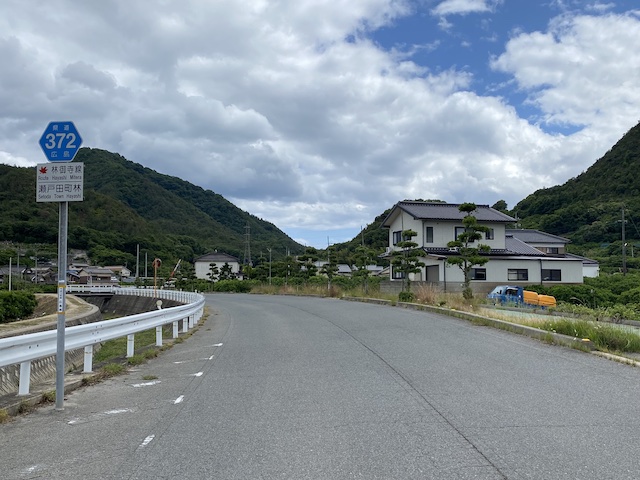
36, 163, 84, 202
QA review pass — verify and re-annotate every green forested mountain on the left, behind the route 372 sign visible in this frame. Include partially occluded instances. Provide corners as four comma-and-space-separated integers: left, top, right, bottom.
0, 148, 304, 265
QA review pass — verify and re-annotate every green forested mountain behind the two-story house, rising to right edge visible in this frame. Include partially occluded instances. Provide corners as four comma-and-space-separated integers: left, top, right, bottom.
335, 123, 640, 271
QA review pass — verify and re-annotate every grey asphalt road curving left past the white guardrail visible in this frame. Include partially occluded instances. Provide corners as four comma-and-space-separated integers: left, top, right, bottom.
0, 294, 640, 480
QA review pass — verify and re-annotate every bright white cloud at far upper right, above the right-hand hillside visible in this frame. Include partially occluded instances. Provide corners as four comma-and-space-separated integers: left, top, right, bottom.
493, 14, 640, 140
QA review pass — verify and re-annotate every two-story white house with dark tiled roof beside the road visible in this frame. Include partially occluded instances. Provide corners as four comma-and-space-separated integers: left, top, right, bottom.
382, 201, 584, 292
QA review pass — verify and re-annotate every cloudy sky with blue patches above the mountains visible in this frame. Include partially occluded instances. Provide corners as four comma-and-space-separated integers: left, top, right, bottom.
0, 0, 640, 248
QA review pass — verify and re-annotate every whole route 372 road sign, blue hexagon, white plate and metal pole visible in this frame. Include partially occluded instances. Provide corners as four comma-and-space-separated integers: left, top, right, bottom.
36, 122, 84, 410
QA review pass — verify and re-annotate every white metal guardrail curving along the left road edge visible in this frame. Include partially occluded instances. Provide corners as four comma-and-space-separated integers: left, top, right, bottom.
0, 286, 204, 395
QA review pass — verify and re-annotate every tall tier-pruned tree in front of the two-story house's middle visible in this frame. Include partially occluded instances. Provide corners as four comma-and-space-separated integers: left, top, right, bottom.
447, 203, 491, 300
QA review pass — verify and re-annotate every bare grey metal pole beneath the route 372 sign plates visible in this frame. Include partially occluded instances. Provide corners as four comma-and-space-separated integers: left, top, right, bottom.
56, 202, 69, 410
